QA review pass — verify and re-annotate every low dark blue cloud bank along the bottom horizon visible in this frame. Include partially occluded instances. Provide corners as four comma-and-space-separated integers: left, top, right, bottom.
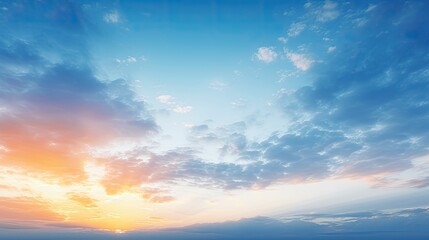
0, 208, 429, 240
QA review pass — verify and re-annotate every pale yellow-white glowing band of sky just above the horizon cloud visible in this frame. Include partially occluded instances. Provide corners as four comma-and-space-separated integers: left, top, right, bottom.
0, 155, 422, 234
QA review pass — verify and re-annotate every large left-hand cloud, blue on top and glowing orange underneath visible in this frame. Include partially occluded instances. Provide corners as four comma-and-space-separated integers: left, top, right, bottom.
0, 3, 158, 183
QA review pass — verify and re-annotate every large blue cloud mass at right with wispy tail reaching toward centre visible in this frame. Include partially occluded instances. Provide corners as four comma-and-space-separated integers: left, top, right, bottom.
148, 0, 429, 189
